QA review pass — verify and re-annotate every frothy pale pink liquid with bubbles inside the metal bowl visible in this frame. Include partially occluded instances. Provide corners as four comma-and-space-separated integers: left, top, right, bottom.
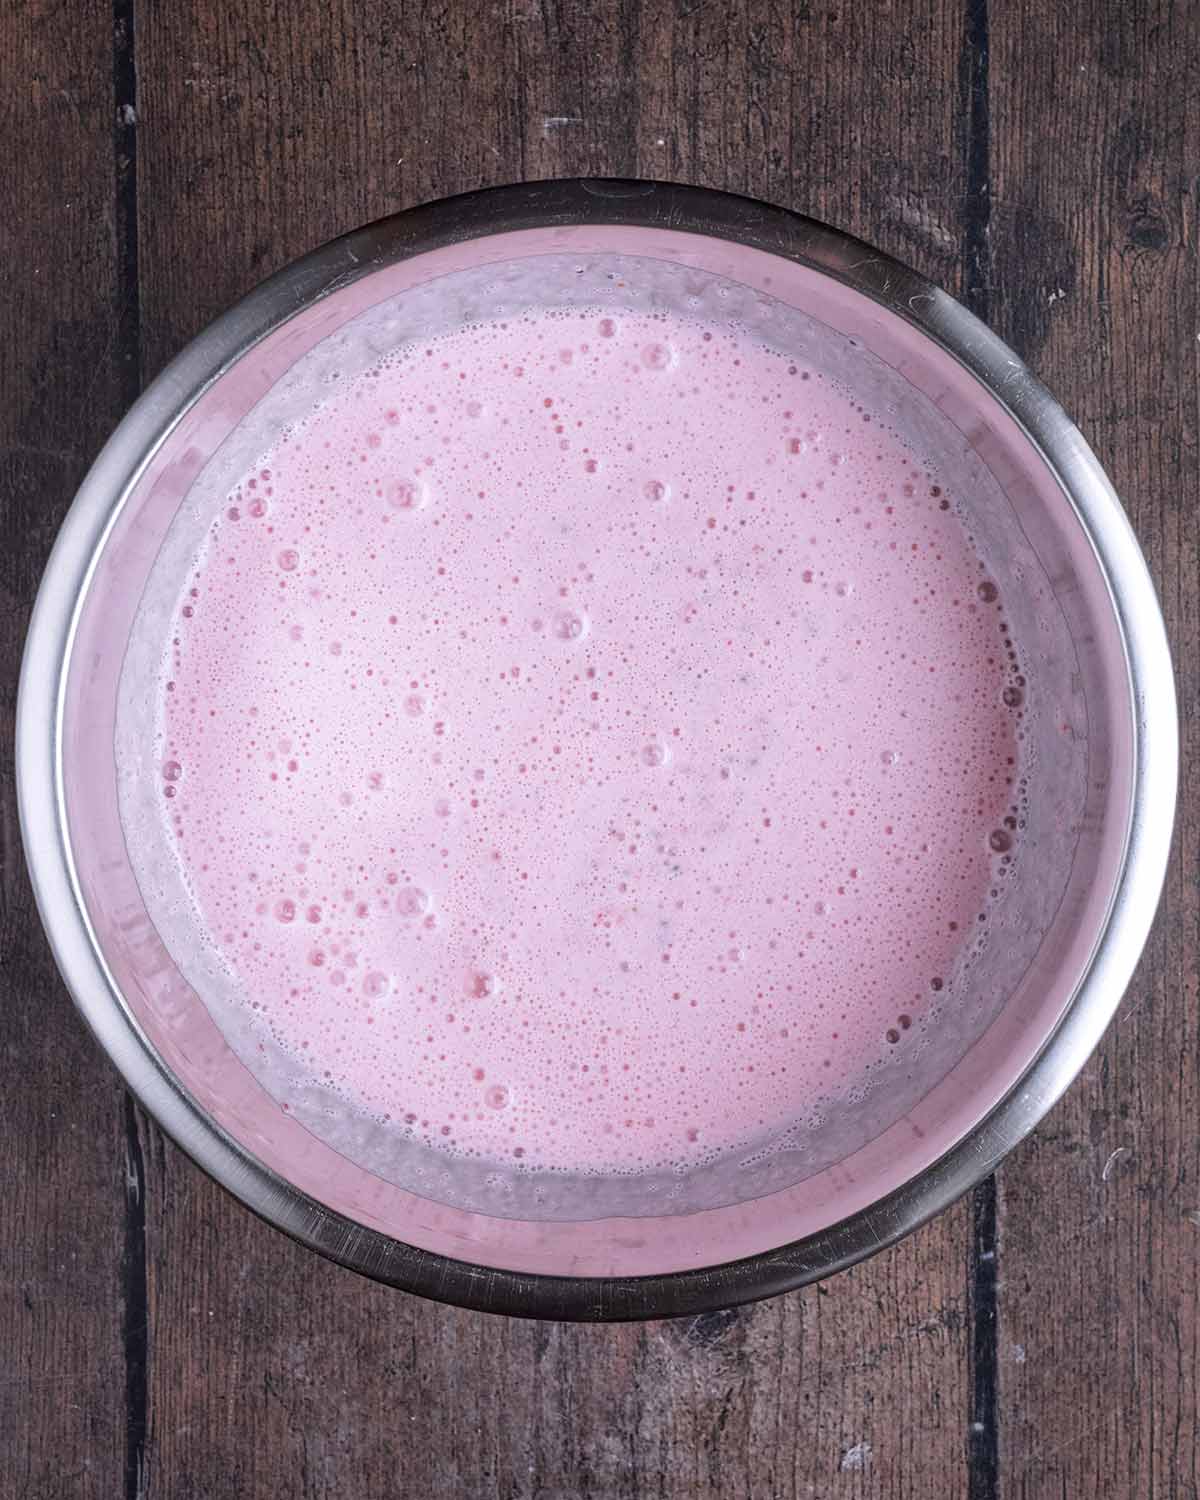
132, 312, 1022, 1172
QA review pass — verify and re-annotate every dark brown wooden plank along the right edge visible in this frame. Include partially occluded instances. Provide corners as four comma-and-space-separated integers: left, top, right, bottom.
992, 0, 1200, 1500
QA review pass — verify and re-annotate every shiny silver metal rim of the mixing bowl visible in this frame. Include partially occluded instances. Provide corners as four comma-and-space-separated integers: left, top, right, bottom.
17, 179, 1178, 1322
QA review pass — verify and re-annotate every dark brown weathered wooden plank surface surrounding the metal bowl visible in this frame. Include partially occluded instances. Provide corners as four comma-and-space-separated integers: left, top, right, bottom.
0, 0, 1200, 1500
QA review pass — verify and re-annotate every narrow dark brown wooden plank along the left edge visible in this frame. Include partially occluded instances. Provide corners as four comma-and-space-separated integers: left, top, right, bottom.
0, 0, 126, 1500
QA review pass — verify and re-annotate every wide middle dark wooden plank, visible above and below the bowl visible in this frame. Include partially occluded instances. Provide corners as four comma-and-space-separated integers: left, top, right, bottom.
138, 0, 969, 1500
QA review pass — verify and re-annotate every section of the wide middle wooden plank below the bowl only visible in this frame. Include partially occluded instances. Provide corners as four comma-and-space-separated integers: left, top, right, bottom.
141, 1134, 965, 1500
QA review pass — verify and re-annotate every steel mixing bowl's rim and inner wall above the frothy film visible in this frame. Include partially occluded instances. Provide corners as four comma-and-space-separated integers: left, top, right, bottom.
18, 182, 1176, 1319
